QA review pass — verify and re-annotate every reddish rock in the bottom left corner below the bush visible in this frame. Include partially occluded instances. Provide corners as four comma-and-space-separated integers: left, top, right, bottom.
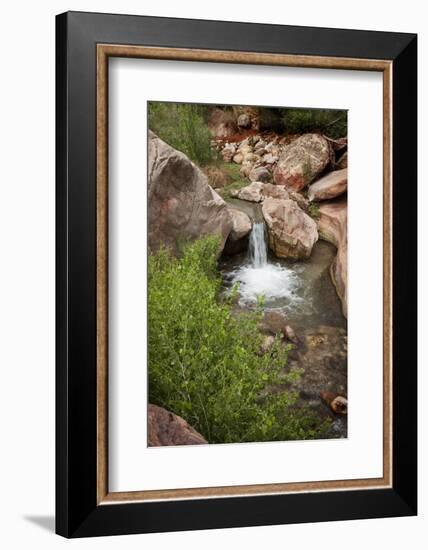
148, 404, 208, 447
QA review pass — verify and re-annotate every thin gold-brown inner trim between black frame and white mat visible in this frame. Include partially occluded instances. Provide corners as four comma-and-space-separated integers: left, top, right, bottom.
97, 44, 392, 505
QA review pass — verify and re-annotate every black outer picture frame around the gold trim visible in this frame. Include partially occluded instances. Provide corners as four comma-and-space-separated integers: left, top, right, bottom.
56, 12, 417, 537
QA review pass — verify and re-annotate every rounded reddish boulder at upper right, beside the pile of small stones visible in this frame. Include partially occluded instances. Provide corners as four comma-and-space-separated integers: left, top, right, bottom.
273, 134, 331, 191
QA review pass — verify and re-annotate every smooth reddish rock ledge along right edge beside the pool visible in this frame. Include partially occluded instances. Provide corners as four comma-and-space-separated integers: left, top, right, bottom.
318, 199, 348, 317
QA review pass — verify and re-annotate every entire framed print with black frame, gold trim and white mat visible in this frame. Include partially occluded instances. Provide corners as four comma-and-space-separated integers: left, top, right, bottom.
56, 12, 417, 537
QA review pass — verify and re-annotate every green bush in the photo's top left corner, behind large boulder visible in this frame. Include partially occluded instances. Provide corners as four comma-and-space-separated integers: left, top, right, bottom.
148, 101, 214, 166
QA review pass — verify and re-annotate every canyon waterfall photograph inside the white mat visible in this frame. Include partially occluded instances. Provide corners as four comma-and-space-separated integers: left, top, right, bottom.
147, 100, 352, 447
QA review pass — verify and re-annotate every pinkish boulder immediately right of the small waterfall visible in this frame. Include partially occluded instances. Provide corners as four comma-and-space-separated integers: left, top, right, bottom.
262, 198, 318, 260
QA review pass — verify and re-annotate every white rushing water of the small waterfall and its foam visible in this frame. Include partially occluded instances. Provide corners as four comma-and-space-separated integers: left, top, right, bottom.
227, 222, 301, 306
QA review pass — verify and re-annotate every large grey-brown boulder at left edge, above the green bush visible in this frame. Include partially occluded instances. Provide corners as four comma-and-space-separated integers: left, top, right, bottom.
148, 131, 232, 253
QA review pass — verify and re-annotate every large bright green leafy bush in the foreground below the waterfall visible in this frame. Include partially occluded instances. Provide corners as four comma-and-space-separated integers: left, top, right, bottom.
148, 237, 317, 443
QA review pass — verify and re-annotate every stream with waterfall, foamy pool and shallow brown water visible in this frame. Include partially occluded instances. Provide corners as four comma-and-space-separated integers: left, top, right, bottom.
220, 199, 347, 438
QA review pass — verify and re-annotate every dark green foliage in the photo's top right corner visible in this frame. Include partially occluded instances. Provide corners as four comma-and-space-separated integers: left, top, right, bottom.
280, 109, 348, 139
